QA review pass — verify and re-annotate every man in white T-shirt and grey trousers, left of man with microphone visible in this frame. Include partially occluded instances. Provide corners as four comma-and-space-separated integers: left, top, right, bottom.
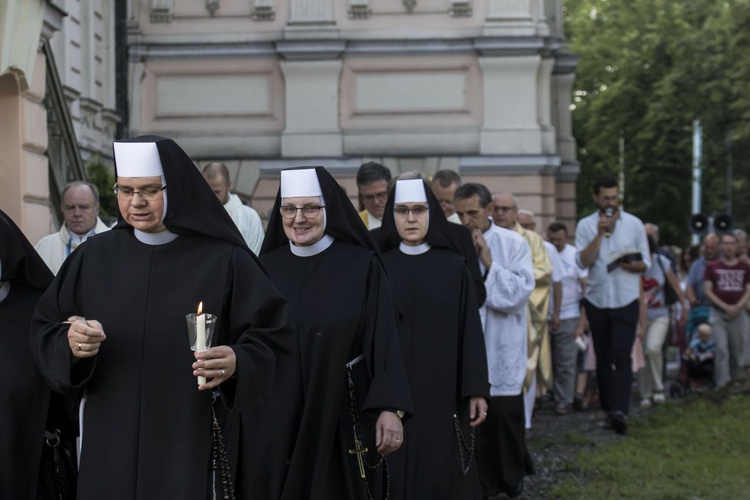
547, 222, 588, 414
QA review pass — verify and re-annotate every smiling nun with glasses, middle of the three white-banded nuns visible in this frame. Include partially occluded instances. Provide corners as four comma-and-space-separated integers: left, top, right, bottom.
260, 167, 412, 500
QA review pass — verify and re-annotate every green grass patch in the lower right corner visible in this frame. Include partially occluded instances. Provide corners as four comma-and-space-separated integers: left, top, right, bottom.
549, 396, 750, 499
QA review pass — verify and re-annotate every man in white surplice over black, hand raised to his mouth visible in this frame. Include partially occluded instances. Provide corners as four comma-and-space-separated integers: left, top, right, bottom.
455, 183, 534, 498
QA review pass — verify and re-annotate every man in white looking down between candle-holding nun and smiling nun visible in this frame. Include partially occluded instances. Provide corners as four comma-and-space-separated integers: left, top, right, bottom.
203, 162, 265, 255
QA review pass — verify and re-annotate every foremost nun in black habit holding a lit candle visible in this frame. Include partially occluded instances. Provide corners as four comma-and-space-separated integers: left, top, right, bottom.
31, 136, 292, 500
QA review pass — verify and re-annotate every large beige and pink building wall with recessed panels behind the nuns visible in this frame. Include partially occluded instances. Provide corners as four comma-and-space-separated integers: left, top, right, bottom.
128, 0, 578, 228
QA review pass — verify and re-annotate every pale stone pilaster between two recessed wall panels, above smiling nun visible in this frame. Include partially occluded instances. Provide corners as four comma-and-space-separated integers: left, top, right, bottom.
281, 59, 343, 158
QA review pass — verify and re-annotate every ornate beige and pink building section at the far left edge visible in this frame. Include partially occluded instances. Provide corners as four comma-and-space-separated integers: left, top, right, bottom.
0, 0, 119, 239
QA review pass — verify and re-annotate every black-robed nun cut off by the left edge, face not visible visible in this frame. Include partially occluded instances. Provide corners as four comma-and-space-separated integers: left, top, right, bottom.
0, 211, 59, 500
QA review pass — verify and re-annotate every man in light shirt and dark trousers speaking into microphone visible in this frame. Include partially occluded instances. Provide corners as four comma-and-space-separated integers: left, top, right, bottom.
576, 175, 651, 434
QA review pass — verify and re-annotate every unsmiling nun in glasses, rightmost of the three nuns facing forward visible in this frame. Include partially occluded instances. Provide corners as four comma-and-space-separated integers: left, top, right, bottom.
380, 179, 490, 500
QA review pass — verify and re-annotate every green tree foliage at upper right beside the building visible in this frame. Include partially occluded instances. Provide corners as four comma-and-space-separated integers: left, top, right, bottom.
565, 0, 750, 245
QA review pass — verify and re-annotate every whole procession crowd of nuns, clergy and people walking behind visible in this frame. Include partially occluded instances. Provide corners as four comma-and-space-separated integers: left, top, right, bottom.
0, 136, 750, 499
